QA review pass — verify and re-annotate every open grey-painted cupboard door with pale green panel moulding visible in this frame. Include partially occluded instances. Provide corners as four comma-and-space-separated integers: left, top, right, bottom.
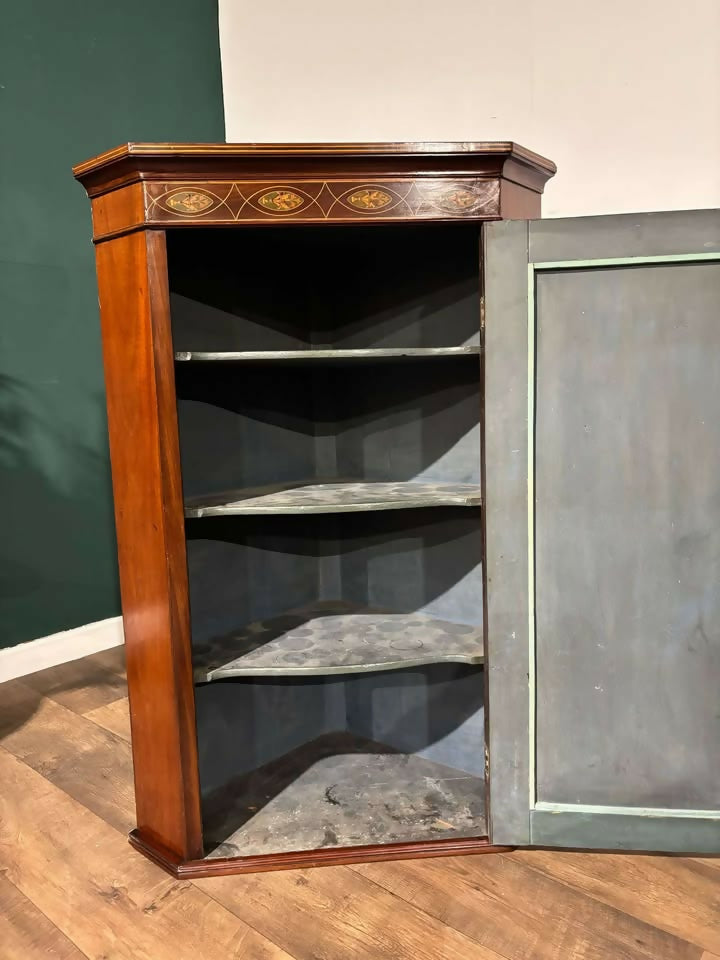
484, 210, 720, 852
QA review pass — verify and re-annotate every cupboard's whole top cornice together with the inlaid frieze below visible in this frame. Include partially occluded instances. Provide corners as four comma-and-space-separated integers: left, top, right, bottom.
73, 142, 555, 240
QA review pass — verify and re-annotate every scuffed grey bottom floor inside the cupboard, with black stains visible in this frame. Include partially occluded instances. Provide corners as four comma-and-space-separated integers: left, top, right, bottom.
203, 733, 487, 859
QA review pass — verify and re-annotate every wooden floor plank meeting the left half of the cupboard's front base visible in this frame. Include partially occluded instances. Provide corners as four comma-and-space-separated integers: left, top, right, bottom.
193, 867, 504, 960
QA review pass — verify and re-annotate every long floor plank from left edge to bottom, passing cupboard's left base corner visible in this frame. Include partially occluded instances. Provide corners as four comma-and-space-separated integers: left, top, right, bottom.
0, 749, 296, 960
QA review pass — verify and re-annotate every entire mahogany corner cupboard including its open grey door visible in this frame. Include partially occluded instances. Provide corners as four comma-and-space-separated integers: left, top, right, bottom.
74, 143, 720, 876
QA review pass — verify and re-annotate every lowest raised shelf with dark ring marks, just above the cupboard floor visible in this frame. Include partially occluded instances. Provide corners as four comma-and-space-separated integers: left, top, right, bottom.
193, 601, 484, 683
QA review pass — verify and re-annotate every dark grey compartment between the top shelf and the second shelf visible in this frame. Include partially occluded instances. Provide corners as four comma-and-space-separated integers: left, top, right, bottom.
176, 355, 480, 498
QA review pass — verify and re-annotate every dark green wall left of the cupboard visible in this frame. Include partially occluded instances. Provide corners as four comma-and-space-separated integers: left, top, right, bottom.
0, 0, 224, 646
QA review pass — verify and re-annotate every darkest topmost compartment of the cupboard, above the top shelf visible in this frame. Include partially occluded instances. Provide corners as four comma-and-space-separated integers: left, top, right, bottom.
168, 223, 480, 351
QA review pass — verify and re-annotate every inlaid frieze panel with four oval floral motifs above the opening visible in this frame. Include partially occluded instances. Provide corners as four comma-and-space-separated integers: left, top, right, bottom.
145, 178, 500, 224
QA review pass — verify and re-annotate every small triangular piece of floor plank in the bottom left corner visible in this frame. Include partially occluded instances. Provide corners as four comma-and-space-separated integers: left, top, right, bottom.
0, 874, 86, 960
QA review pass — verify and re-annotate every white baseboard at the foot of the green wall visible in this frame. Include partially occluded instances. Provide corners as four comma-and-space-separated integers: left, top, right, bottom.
0, 617, 125, 683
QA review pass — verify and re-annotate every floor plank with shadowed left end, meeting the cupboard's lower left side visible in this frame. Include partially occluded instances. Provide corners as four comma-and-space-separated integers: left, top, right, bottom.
0, 680, 135, 834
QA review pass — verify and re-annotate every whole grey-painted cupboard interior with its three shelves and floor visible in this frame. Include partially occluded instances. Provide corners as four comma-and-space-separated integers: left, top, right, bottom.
168, 224, 487, 857
